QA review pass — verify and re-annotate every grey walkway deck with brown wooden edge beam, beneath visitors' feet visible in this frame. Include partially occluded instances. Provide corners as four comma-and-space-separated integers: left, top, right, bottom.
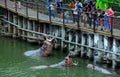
0, 0, 120, 38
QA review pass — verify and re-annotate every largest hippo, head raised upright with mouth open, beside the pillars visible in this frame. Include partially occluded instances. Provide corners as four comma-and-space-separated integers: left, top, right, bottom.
24, 35, 54, 57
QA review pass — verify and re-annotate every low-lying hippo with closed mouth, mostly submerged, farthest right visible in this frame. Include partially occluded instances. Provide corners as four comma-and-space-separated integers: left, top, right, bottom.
87, 64, 117, 75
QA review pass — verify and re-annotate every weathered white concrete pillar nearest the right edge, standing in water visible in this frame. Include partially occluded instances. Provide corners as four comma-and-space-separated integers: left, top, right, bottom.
112, 38, 117, 69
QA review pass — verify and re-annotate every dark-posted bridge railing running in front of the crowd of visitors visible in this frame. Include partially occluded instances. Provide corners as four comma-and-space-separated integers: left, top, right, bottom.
1, 0, 120, 35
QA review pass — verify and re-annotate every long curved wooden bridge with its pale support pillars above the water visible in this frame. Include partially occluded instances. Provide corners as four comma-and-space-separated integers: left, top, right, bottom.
0, 0, 120, 68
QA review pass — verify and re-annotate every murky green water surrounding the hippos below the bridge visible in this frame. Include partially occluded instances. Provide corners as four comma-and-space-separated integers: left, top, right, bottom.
0, 37, 119, 77
